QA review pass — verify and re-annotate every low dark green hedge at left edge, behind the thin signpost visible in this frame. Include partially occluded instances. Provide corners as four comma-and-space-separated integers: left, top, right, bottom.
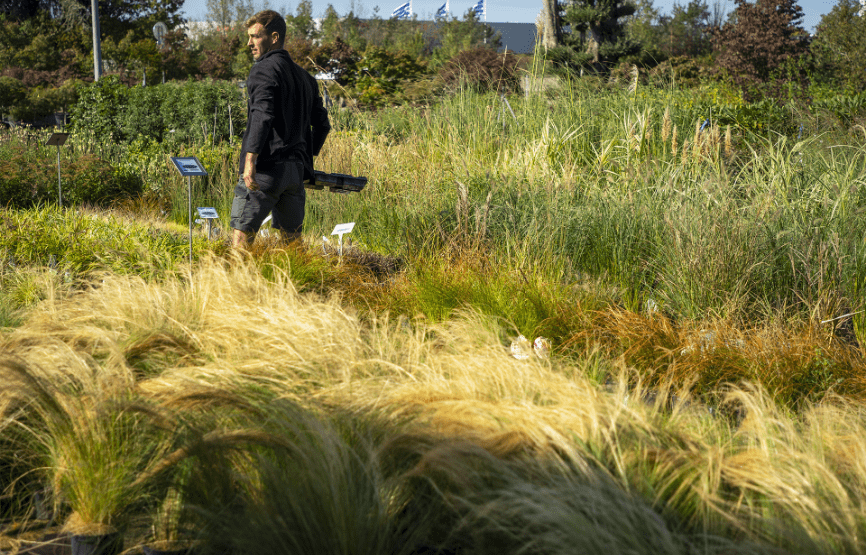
0, 146, 142, 208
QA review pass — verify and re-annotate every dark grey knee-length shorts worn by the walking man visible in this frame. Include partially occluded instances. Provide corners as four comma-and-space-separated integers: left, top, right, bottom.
231, 160, 307, 233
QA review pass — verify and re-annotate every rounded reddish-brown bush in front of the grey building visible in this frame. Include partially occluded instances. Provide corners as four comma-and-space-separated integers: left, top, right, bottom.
439, 47, 519, 92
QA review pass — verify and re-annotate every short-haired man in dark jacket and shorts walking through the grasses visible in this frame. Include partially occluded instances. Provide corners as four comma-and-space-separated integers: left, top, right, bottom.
231, 10, 331, 247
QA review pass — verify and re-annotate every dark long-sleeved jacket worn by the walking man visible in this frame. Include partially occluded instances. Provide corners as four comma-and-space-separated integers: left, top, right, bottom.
240, 50, 331, 180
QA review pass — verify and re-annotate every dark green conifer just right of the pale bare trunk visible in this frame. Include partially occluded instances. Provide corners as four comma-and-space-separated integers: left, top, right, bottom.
551, 0, 640, 71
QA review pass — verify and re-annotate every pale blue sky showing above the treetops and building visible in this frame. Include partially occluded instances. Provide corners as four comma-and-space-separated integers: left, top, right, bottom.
183, 0, 836, 32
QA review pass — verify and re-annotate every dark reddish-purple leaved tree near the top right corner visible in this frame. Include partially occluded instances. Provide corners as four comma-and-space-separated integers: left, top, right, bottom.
714, 0, 808, 97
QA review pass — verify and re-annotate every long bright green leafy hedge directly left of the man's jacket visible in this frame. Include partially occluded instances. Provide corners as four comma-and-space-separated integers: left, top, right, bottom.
70, 76, 247, 148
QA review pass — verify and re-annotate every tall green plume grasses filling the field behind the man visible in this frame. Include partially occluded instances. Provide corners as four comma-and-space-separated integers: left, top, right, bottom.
6, 81, 866, 335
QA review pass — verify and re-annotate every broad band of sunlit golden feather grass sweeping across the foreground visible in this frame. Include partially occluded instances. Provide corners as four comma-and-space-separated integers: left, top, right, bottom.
2, 258, 866, 552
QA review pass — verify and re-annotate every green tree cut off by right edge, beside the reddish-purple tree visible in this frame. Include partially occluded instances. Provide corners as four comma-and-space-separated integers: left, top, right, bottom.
812, 0, 866, 93
